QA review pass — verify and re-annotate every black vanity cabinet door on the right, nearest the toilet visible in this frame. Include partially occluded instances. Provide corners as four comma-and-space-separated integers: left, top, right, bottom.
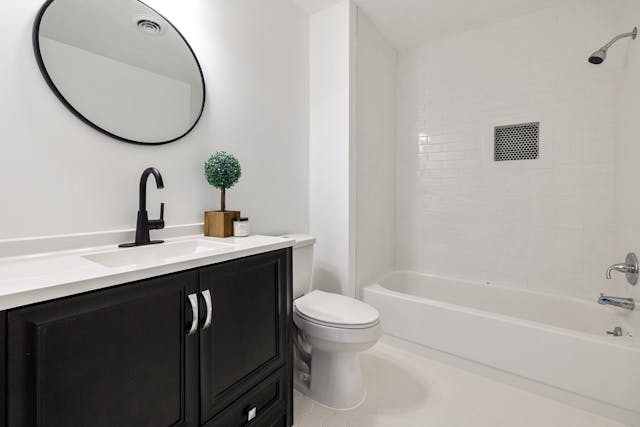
200, 249, 292, 427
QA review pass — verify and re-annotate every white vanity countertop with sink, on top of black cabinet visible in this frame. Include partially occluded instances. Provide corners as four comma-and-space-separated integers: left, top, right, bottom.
0, 235, 294, 311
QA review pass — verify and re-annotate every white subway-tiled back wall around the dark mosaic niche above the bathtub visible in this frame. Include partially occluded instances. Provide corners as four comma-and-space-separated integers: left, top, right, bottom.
396, 0, 624, 300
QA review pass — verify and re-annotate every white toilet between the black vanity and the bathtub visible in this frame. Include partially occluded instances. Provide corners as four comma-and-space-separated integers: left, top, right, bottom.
285, 234, 381, 409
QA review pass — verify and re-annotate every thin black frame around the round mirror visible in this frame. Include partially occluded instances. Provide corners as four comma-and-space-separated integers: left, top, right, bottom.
32, 0, 207, 145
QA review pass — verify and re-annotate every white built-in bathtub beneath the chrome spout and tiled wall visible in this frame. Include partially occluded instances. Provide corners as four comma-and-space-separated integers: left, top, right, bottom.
362, 272, 640, 426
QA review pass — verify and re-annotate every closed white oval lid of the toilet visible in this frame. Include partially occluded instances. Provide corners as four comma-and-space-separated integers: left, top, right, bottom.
294, 291, 380, 328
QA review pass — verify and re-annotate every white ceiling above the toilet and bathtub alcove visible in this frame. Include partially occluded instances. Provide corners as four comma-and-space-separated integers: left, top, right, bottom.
293, 0, 564, 50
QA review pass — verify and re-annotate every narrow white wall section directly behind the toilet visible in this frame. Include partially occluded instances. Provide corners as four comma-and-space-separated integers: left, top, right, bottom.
309, 0, 355, 295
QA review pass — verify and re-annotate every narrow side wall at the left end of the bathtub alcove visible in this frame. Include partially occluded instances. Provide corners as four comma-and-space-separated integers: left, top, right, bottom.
355, 9, 397, 287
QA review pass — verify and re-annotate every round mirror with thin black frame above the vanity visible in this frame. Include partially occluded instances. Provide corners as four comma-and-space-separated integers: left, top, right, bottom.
33, 0, 205, 144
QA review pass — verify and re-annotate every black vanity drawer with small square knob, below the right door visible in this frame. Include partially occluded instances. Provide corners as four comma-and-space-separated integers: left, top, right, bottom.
204, 369, 289, 427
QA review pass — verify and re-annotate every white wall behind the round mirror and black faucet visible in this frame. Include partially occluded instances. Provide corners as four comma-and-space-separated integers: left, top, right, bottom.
0, 0, 309, 239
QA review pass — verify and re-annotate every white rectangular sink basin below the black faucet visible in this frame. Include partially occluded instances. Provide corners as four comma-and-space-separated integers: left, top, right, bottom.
83, 239, 234, 267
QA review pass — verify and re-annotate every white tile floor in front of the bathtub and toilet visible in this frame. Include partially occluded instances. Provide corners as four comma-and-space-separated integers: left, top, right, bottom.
294, 344, 623, 427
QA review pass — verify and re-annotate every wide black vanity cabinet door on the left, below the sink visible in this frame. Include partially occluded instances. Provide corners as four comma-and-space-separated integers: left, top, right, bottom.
8, 271, 199, 427
